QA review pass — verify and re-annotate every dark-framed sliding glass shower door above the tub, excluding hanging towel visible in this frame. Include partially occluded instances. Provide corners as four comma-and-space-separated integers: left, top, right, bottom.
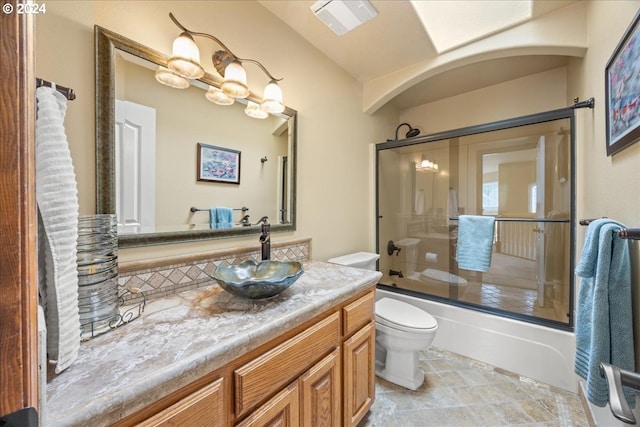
377, 109, 574, 329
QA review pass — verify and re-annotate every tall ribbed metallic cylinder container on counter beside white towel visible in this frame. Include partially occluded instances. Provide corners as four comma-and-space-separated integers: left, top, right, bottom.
77, 214, 120, 339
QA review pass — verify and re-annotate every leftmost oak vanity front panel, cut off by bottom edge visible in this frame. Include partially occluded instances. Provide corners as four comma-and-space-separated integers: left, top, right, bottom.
138, 378, 227, 427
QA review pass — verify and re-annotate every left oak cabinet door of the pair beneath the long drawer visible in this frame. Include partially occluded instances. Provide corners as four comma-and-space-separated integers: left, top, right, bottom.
236, 381, 300, 427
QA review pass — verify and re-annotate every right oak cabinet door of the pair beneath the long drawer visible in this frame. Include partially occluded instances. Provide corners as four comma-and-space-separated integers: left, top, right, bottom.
300, 348, 341, 427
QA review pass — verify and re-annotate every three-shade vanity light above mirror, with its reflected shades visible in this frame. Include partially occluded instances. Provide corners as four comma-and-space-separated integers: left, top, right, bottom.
156, 13, 285, 118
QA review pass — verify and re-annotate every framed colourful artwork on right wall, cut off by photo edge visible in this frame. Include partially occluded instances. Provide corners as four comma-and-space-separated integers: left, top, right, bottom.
605, 12, 640, 156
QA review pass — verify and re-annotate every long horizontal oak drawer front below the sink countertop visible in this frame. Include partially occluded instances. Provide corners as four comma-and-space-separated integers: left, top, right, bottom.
234, 313, 340, 417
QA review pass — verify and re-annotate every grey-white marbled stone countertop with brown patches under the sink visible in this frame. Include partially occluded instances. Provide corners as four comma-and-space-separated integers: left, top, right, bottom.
44, 262, 381, 427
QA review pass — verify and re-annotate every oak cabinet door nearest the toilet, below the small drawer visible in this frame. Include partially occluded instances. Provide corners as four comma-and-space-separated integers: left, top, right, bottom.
342, 322, 375, 427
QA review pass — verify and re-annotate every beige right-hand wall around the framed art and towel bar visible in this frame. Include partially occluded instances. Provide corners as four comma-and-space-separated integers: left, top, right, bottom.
570, 1, 640, 388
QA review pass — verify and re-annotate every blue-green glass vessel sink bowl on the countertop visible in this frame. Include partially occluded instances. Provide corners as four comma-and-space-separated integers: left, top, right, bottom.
212, 260, 304, 299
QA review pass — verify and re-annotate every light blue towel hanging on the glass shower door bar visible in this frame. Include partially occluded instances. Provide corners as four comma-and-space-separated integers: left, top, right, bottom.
456, 215, 496, 271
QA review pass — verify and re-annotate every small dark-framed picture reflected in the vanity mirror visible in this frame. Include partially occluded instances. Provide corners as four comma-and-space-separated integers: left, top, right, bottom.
197, 142, 241, 184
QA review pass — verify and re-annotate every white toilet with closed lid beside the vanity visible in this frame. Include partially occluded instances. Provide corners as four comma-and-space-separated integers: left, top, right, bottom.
329, 252, 438, 390
